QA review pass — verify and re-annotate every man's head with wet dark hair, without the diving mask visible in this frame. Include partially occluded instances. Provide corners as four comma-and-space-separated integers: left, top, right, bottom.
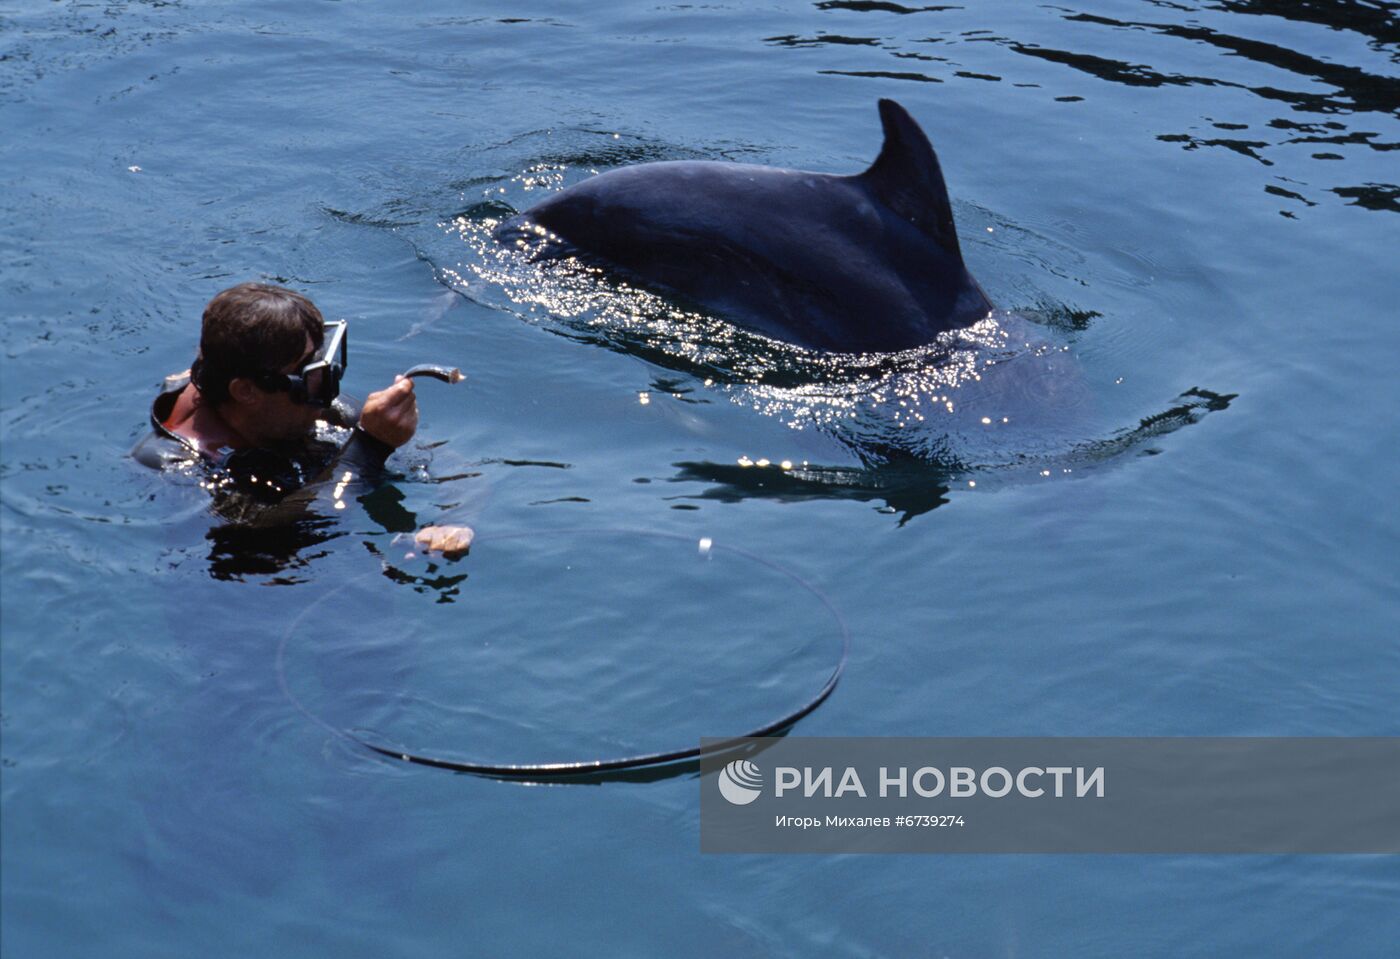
192, 283, 325, 441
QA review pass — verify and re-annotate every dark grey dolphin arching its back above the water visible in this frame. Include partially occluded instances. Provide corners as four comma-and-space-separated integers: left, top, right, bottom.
494, 99, 993, 353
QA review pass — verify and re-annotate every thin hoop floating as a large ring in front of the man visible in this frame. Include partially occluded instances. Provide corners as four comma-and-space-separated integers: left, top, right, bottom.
276, 529, 851, 780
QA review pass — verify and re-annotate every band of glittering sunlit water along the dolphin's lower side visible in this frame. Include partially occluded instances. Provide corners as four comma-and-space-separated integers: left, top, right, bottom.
440, 212, 1051, 442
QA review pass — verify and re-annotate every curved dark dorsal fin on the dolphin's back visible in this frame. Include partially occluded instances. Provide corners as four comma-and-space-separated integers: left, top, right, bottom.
858, 99, 962, 262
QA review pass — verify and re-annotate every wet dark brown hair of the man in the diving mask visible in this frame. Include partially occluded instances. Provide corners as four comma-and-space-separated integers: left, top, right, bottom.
190, 283, 325, 406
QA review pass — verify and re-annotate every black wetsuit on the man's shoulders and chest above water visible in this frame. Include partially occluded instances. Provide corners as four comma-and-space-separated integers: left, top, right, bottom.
132, 375, 393, 519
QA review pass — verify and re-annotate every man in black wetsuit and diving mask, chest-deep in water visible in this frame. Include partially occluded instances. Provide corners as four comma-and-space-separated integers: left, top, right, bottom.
132, 283, 473, 556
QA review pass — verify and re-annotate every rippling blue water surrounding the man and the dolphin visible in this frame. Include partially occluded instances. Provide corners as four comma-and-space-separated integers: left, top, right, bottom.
0, 0, 1400, 958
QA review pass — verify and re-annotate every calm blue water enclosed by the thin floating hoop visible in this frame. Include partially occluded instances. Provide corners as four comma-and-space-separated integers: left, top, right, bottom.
279, 529, 843, 763
